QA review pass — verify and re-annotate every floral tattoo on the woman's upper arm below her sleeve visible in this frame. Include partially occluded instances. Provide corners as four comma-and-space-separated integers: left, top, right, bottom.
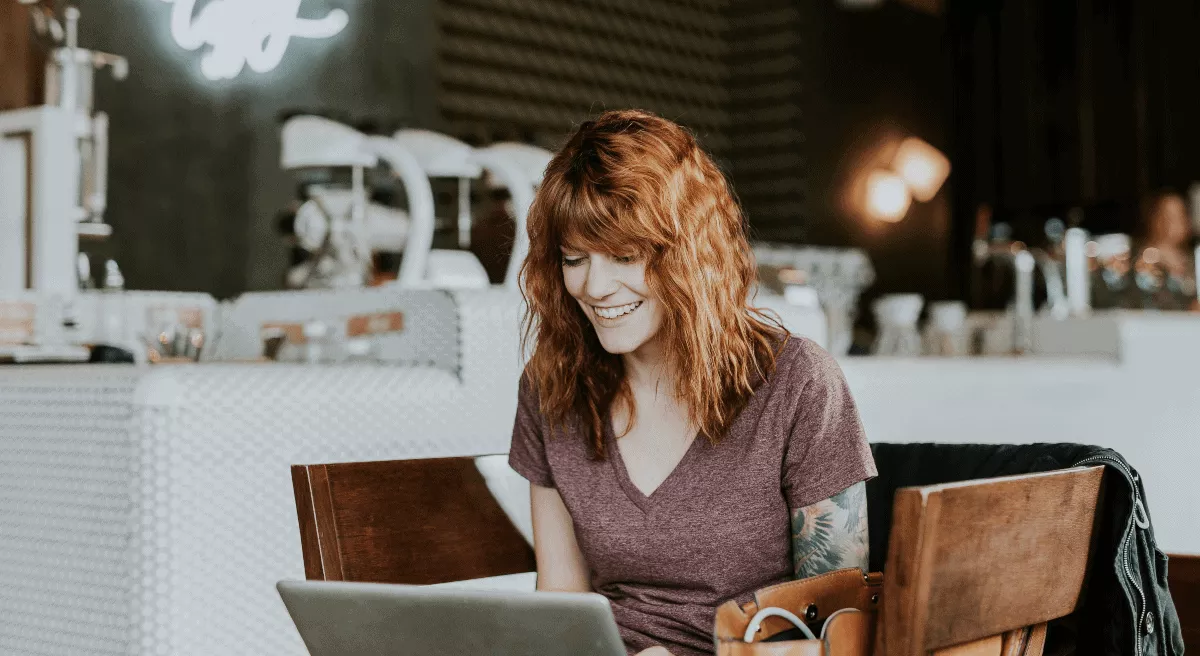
792, 482, 869, 578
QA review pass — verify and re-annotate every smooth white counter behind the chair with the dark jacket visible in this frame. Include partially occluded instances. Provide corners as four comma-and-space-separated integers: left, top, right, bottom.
841, 357, 1200, 553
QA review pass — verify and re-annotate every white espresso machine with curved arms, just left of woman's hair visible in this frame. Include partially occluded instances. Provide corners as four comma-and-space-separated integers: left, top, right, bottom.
281, 115, 553, 290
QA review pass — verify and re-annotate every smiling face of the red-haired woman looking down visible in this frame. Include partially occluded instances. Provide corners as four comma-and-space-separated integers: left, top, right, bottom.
563, 248, 662, 355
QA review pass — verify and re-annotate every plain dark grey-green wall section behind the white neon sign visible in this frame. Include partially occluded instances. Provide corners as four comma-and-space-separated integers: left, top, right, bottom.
78, 0, 436, 296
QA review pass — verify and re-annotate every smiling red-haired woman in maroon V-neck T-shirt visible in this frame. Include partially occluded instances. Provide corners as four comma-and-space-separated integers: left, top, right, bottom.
509, 112, 875, 656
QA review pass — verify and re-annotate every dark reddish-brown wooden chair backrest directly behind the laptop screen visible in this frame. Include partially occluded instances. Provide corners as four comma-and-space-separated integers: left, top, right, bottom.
292, 458, 536, 584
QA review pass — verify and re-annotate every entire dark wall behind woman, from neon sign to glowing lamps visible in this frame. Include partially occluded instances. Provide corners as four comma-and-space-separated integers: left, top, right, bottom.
80, 0, 944, 296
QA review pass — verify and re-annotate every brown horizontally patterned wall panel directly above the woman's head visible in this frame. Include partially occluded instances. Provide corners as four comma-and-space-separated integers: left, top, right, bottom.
436, 0, 728, 149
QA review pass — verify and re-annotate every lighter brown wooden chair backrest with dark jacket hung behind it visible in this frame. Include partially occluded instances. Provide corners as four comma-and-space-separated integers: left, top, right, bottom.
876, 467, 1104, 656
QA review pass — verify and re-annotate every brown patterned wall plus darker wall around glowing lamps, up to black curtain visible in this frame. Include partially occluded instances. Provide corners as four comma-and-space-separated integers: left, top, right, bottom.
438, 0, 949, 304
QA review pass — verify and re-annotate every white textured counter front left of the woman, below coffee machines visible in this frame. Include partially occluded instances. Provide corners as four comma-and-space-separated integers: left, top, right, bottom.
0, 293, 521, 656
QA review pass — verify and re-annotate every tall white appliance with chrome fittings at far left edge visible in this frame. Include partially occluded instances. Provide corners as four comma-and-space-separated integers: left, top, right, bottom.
0, 1, 128, 295
